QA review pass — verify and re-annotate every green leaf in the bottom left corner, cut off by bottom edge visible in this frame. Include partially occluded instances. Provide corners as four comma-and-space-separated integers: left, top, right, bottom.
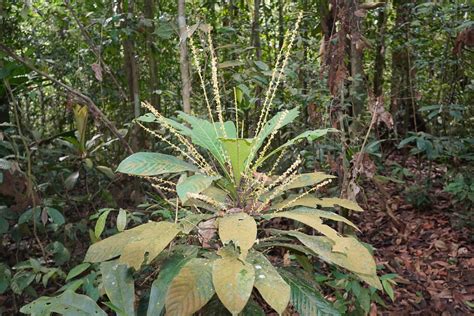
20, 291, 107, 316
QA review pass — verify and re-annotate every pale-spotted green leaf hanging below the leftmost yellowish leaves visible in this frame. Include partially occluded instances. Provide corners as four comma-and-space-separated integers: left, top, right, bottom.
100, 261, 135, 316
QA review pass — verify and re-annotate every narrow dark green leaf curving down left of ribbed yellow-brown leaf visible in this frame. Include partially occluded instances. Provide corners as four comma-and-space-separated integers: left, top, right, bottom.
146, 249, 197, 316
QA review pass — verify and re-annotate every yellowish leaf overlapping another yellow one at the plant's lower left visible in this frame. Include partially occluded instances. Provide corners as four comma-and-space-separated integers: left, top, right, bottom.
119, 222, 179, 270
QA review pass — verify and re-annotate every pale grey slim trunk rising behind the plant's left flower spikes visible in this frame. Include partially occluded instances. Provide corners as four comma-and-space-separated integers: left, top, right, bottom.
178, 0, 191, 113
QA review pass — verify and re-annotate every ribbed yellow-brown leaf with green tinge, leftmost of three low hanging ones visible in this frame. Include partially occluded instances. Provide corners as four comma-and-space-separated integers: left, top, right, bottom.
165, 258, 215, 316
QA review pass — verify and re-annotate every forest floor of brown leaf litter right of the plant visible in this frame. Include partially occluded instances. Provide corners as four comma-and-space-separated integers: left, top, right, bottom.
355, 158, 474, 315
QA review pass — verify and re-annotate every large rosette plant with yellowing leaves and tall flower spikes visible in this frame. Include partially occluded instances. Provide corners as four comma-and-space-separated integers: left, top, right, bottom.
23, 12, 381, 315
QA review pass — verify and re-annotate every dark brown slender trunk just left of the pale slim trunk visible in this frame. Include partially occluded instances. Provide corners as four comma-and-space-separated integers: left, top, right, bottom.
144, 0, 161, 110
